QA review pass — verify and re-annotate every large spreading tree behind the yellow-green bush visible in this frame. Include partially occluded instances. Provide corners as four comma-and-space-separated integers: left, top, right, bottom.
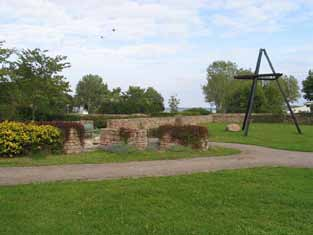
11, 48, 70, 120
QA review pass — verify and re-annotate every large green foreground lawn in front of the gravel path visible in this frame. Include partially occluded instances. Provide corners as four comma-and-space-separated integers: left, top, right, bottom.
0, 168, 313, 235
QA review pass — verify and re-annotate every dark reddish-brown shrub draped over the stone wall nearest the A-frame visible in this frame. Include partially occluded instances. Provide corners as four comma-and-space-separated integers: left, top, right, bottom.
157, 125, 209, 148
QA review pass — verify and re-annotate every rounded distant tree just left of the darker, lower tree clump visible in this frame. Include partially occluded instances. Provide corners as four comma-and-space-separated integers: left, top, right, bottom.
75, 74, 109, 113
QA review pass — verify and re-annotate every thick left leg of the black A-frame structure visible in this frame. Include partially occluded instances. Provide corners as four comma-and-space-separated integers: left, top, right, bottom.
243, 49, 263, 136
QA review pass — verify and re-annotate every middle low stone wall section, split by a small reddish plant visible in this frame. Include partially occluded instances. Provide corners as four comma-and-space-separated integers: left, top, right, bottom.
100, 128, 148, 150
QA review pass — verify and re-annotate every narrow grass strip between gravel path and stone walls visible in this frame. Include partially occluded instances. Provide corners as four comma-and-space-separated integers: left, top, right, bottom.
0, 147, 240, 167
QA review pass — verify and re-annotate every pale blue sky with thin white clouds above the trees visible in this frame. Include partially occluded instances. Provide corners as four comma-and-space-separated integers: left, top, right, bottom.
0, 0, 313, 107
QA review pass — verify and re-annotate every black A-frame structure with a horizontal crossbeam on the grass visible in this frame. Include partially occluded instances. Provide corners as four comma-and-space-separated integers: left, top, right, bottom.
234, 48, 302, 136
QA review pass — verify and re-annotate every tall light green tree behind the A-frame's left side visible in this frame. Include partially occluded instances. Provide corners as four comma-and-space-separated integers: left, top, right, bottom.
202, 61, 251, 112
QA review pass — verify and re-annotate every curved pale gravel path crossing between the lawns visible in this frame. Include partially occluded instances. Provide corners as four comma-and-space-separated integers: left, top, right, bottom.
0, 143, 313, 185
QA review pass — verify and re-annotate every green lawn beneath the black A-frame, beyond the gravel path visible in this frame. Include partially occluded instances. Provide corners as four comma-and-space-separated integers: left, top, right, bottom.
207, 123, 313, 152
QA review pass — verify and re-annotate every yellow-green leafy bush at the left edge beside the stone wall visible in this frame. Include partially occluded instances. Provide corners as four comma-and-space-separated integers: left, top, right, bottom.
0, 121, 63, 157
